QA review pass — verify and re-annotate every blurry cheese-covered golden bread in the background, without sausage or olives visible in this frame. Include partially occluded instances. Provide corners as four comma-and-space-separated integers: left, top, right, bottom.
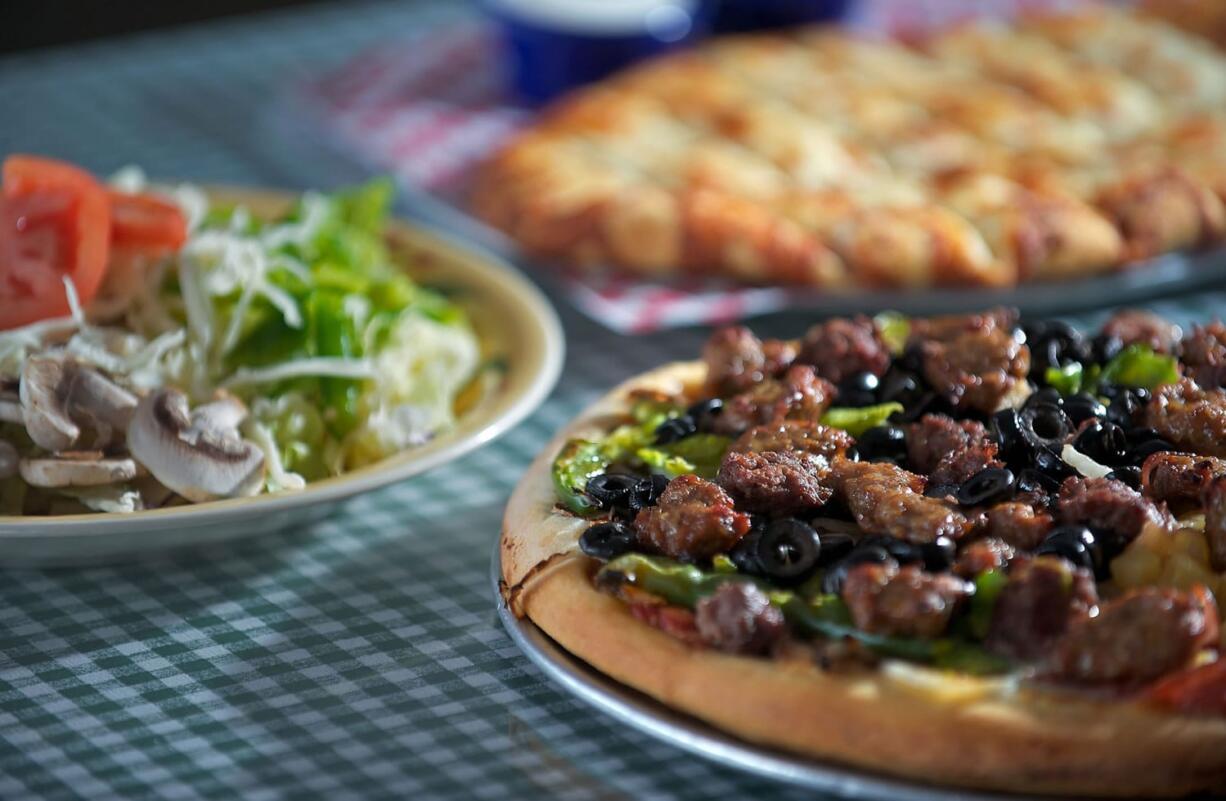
471, 7, 1226, 289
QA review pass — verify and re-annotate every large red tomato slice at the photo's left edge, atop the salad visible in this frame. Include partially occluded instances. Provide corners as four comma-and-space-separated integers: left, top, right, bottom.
0, 156, 110, 330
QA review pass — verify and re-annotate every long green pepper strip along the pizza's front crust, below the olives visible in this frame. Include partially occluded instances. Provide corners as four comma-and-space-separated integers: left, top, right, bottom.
598, 553, 1009, 675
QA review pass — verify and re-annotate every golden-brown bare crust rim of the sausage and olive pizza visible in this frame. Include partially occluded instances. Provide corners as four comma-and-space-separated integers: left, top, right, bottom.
500, 362, 1226, 797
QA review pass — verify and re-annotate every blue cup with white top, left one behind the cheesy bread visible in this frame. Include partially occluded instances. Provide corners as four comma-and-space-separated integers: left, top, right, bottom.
484, 0, 711, 104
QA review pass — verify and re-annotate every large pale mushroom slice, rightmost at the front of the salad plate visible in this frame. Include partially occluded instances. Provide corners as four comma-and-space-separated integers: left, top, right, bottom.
128, 389, 264, 502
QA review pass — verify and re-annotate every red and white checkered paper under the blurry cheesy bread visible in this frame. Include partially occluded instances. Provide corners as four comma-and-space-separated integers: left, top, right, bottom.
300, 0, 1075, 332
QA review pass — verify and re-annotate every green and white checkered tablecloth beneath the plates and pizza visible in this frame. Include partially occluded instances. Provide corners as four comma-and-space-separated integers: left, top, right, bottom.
0, 2, 1226, 801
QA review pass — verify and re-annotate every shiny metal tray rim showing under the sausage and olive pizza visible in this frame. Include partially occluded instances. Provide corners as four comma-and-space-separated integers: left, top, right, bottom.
489, 542, 1043, 801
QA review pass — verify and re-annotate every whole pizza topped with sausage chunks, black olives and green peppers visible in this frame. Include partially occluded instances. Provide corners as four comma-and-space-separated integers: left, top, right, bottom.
500, 309, 1226, 797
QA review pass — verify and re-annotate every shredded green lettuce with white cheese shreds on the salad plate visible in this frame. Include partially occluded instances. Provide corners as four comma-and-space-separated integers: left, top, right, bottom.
112, 174, 481, 491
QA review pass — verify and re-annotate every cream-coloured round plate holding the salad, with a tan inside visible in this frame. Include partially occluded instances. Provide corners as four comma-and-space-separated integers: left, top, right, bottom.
0, 188, 564, 567
